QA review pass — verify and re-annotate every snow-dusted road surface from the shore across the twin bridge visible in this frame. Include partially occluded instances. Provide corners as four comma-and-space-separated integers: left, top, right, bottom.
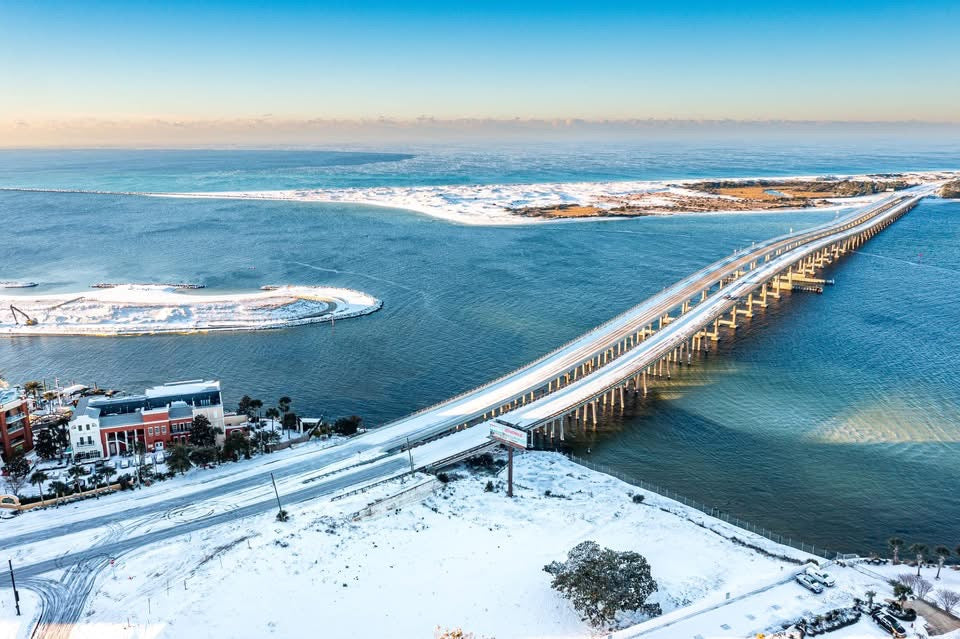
0, 187, 933, 604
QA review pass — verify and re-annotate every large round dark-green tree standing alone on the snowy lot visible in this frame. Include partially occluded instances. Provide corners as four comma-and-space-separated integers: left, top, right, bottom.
543, 541, 660, 627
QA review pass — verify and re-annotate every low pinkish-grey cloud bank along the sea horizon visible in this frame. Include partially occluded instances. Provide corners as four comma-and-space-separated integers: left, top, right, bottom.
0, 114, 960, 148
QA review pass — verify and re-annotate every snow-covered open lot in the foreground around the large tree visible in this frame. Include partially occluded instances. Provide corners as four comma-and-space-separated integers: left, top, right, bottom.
0, 452, 944, 639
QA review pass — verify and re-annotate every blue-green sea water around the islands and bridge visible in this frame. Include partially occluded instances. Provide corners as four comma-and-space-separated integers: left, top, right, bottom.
0, 145, 960, 550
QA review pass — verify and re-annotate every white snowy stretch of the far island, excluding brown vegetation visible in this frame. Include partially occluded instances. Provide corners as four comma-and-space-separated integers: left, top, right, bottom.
143, 172, 952, 225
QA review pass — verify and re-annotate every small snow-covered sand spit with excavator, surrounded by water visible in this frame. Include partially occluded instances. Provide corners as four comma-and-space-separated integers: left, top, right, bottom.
0, 284, 383, 335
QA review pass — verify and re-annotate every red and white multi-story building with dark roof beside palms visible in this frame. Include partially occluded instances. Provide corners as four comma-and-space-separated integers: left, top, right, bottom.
70, 380, 224, 460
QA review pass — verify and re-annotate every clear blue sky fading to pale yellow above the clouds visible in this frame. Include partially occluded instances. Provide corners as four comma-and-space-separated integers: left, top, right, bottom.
0, 0, 960, 144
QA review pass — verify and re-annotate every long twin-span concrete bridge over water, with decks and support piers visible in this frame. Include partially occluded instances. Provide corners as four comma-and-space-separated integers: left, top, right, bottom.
366, 186, 935, 460
